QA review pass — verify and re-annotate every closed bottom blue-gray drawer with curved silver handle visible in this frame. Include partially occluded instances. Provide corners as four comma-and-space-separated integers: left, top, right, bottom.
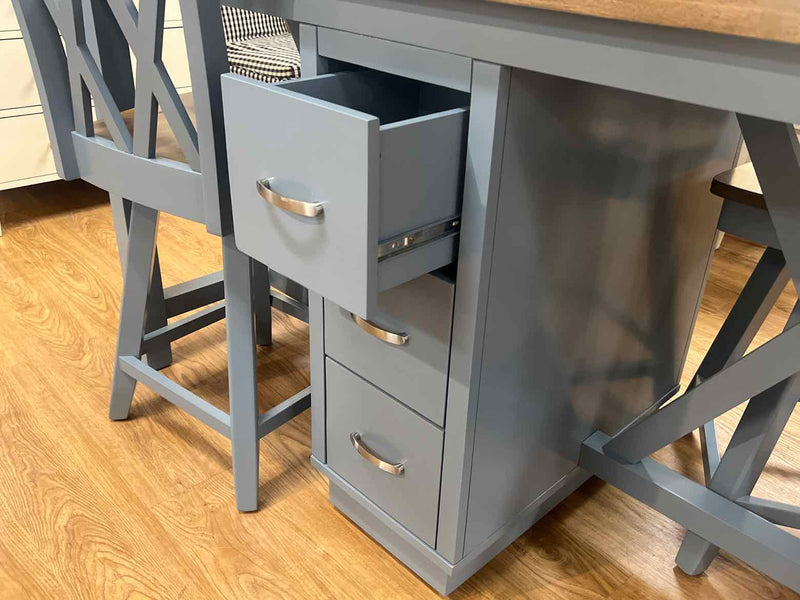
325, 358, 443, 547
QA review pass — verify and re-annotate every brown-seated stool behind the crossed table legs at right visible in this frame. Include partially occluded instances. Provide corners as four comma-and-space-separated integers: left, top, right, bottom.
676, 163, 800, 574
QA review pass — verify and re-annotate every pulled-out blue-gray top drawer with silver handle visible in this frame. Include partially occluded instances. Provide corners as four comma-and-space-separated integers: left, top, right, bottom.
223, 70, 468, 318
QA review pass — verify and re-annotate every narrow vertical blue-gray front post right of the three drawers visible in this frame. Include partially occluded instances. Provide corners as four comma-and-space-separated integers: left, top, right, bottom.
436, 61, 511, 563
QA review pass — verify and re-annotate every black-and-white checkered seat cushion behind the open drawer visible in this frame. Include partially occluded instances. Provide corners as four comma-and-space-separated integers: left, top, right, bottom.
222, 5, 300, 83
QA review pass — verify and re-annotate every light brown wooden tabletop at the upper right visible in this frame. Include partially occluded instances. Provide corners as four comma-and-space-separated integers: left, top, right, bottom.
484, 0, 800, 44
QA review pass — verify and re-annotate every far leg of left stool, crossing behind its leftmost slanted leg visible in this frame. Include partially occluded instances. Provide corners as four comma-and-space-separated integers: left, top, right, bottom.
109, 194, 172, 370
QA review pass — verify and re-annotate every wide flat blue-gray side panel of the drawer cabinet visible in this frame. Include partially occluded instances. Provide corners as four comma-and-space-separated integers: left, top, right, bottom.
466, 70, 738, 551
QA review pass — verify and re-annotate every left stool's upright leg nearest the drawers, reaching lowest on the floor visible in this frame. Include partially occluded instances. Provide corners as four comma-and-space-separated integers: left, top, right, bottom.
222, 235, 259, 512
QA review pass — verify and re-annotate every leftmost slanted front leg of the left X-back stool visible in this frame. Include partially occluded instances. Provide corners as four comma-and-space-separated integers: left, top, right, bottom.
109, 204, 158, 420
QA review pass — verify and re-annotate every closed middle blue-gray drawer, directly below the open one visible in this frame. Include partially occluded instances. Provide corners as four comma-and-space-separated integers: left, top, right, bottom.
325, 274, 454, 425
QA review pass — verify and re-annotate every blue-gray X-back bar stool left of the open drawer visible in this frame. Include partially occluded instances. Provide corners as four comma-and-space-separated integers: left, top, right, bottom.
13, 0, 310, 511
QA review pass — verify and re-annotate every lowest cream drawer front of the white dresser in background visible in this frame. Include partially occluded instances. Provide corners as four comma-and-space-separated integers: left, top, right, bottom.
0, 113, 56, 182
